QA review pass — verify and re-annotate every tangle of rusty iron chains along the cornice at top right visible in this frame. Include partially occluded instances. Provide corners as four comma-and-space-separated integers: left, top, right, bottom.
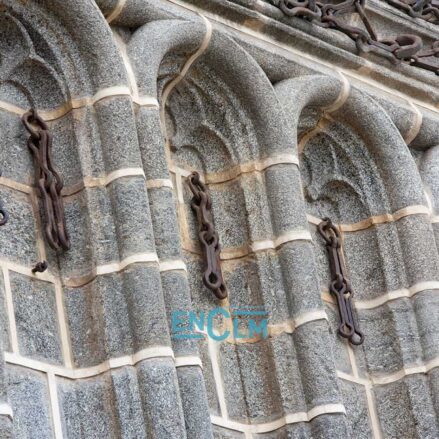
271, 0, 439, 75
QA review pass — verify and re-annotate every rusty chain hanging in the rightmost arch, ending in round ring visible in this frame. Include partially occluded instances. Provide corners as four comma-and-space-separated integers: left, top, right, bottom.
318, 218, 364, 345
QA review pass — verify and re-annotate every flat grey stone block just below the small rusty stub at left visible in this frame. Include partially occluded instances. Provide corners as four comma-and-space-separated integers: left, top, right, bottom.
10, 272, 63, 364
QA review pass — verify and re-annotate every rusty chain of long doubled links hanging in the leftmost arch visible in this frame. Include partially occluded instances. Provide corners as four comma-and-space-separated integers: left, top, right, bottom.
22, 109, 70, 250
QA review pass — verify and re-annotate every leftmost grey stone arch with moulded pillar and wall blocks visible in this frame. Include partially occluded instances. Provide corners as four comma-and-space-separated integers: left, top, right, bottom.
0, 0, 212, 439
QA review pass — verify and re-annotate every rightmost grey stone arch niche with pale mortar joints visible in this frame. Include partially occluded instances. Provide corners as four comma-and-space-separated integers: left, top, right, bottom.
275, 76, 439, 437
